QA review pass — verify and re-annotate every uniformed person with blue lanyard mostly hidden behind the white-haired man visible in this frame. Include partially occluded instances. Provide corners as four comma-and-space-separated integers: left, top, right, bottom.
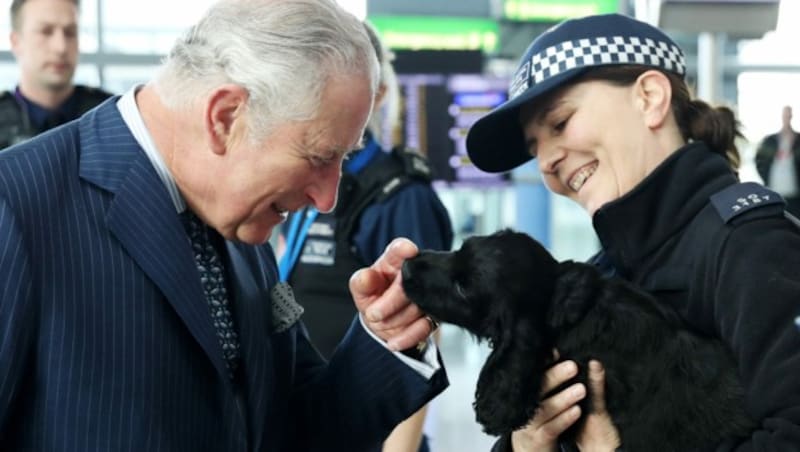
278, 22, 453, 452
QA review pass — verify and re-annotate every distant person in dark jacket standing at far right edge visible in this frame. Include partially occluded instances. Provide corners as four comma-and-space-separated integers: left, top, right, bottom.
756, 105, 800, 217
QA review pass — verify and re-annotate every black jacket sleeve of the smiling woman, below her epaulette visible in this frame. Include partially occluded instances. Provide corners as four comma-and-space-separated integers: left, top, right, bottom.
702, 217, 800, 452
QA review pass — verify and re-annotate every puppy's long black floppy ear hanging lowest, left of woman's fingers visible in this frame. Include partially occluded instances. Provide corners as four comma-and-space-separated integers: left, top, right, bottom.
474, 321, 552, 435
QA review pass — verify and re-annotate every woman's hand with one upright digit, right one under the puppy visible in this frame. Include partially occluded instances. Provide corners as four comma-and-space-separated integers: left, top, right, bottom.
580, 361, 620, 452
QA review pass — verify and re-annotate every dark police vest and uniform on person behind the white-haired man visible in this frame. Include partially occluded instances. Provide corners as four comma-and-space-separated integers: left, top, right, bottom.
282, 145, 453, 358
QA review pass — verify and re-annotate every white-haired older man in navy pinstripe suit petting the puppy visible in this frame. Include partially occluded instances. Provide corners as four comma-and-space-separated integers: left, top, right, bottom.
0, 0, 447, 452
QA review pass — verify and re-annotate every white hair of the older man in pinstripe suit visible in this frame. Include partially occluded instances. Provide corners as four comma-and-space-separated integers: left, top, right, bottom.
155, 0, 378, 140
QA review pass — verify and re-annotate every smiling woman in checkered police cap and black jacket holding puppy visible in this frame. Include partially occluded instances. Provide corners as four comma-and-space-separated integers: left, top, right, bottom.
467, 14, 800, 452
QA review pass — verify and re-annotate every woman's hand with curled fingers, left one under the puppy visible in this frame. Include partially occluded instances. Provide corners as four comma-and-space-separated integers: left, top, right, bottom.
511, 361, 586, 452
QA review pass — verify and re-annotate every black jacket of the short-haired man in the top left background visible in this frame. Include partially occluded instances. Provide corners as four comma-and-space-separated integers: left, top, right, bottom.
0, 85, 111, 150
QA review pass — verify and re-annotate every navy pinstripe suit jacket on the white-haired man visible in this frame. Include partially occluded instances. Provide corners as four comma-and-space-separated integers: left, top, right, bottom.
0, 98, 446, 452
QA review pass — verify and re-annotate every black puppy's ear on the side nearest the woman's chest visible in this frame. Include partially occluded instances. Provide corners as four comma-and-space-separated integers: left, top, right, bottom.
547, 261, 602, 330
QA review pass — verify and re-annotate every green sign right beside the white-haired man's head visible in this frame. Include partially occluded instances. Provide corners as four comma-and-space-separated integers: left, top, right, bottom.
368, 16, 500, 53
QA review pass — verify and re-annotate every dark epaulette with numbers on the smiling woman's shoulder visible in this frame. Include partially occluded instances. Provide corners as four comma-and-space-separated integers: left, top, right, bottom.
710, 182, 786, 223
